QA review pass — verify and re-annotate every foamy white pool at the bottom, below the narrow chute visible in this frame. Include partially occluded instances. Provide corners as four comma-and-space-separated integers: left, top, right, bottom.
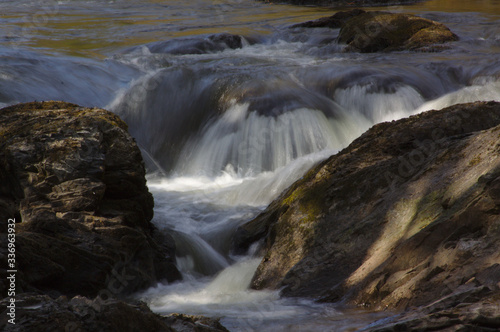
139, 259, 356, 331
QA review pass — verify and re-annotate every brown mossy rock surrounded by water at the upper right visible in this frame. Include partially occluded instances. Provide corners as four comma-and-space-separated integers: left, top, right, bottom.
292, 9, 458, 53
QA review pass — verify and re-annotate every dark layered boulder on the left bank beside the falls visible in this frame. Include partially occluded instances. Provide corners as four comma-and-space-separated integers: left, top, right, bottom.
0, 102, 180, 298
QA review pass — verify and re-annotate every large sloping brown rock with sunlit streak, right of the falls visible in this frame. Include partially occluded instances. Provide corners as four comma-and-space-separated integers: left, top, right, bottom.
235, 102, 500, 320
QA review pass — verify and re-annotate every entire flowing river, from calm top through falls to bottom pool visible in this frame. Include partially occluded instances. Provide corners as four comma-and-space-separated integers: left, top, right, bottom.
0, 0, 500, 331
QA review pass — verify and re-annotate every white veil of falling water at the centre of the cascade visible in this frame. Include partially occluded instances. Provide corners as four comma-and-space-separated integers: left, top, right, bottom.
176, 103, 366, 176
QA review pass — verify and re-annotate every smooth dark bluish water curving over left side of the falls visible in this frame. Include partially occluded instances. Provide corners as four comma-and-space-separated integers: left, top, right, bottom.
109, 66, 227, 172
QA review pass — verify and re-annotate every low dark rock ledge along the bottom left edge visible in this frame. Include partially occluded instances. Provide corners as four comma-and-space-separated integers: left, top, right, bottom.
2, 294, 227, 332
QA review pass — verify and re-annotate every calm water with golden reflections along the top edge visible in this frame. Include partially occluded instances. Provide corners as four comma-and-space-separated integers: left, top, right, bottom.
0, 0, 500, 57
